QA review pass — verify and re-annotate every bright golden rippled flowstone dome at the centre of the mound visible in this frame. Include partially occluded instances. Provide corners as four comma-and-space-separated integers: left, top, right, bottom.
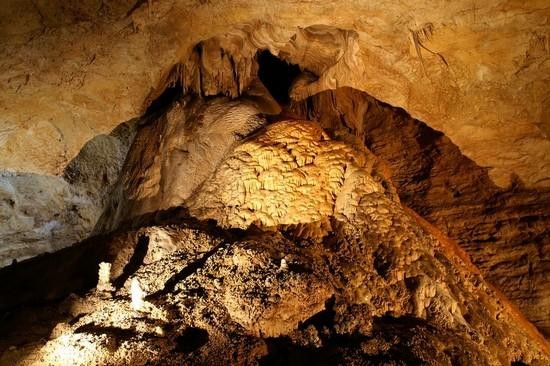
188, 120, 392, 228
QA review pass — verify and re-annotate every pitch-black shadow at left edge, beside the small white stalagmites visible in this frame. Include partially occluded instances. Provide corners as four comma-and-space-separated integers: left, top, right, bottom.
0, 230, 114, 354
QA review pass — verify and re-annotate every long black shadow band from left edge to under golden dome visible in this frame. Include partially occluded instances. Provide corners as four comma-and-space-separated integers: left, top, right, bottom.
0, 207, 239, 314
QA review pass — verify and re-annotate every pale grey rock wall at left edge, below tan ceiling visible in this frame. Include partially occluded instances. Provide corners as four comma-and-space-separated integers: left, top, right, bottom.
0, 123, 134, 267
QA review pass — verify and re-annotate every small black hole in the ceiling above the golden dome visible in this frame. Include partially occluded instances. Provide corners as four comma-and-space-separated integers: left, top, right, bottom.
257, 50, 301, 106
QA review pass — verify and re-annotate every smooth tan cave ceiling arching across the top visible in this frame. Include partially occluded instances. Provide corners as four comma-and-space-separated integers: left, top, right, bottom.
0, 0, 550, 186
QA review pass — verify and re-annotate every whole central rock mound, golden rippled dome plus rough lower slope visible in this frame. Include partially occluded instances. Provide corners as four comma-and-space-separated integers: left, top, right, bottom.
0, 118, 550, 365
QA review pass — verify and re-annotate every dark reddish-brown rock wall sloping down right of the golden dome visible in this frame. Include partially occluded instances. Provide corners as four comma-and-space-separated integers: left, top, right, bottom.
294, 88, 550, 334
